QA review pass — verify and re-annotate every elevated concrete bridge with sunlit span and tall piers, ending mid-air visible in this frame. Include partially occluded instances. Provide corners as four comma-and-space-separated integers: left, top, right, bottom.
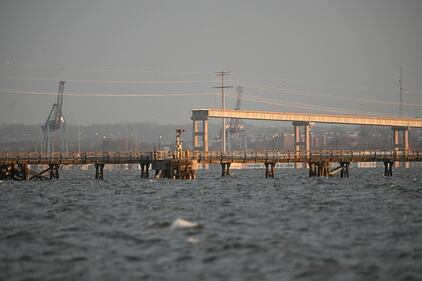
191, 108, 422, 160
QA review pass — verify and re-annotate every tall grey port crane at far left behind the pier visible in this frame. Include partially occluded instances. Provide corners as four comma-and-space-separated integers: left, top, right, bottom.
41, 81, 68, 152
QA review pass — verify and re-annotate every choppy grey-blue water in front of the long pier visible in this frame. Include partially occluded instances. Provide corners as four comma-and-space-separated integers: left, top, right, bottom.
0, 169, 422, 280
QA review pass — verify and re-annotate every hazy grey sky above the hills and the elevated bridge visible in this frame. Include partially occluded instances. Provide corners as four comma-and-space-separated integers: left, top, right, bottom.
0, 0, 422, 124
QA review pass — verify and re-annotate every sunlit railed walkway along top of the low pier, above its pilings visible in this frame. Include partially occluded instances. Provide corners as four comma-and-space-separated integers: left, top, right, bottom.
0, 150, 422, 164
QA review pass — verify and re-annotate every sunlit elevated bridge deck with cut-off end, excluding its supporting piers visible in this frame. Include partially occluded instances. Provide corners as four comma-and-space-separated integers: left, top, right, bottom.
192, 108, 422, 128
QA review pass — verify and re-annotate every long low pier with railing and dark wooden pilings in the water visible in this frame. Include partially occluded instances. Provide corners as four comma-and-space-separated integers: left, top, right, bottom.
0, 150, 422, 181
